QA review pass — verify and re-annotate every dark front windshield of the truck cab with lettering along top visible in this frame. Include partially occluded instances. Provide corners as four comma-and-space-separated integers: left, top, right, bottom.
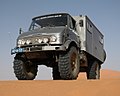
29, 15, 67, 30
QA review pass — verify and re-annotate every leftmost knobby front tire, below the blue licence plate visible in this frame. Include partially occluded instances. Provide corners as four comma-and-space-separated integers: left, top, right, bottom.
13, 59, 38, 80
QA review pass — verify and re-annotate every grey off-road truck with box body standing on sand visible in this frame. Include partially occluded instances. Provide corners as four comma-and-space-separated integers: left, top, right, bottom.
11, 13, 106, 80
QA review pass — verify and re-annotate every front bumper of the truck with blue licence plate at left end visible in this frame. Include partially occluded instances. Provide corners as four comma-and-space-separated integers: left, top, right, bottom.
11, 46, 66, 55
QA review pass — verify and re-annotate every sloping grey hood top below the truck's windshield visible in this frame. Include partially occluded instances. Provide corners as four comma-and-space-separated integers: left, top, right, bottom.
18, 27, 66, 39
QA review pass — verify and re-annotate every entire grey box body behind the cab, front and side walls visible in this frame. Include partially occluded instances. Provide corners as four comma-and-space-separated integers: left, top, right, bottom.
74, 16, 104, 62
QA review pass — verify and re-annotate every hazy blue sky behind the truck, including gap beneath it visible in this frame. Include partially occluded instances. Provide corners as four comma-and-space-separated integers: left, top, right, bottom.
0, 0, 120, 80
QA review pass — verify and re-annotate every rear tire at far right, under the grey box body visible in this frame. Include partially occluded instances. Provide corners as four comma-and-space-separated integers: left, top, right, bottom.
87, 61, 100, 79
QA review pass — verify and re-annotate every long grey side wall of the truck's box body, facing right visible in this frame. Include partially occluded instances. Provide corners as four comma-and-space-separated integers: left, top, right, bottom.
86, 17, 104, 62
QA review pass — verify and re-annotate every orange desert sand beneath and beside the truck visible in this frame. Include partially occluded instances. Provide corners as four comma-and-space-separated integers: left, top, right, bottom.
0, 70, 120, 96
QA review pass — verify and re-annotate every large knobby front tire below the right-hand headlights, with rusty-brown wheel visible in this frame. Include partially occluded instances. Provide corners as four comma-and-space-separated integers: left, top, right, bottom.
58, 46, 80, 80
